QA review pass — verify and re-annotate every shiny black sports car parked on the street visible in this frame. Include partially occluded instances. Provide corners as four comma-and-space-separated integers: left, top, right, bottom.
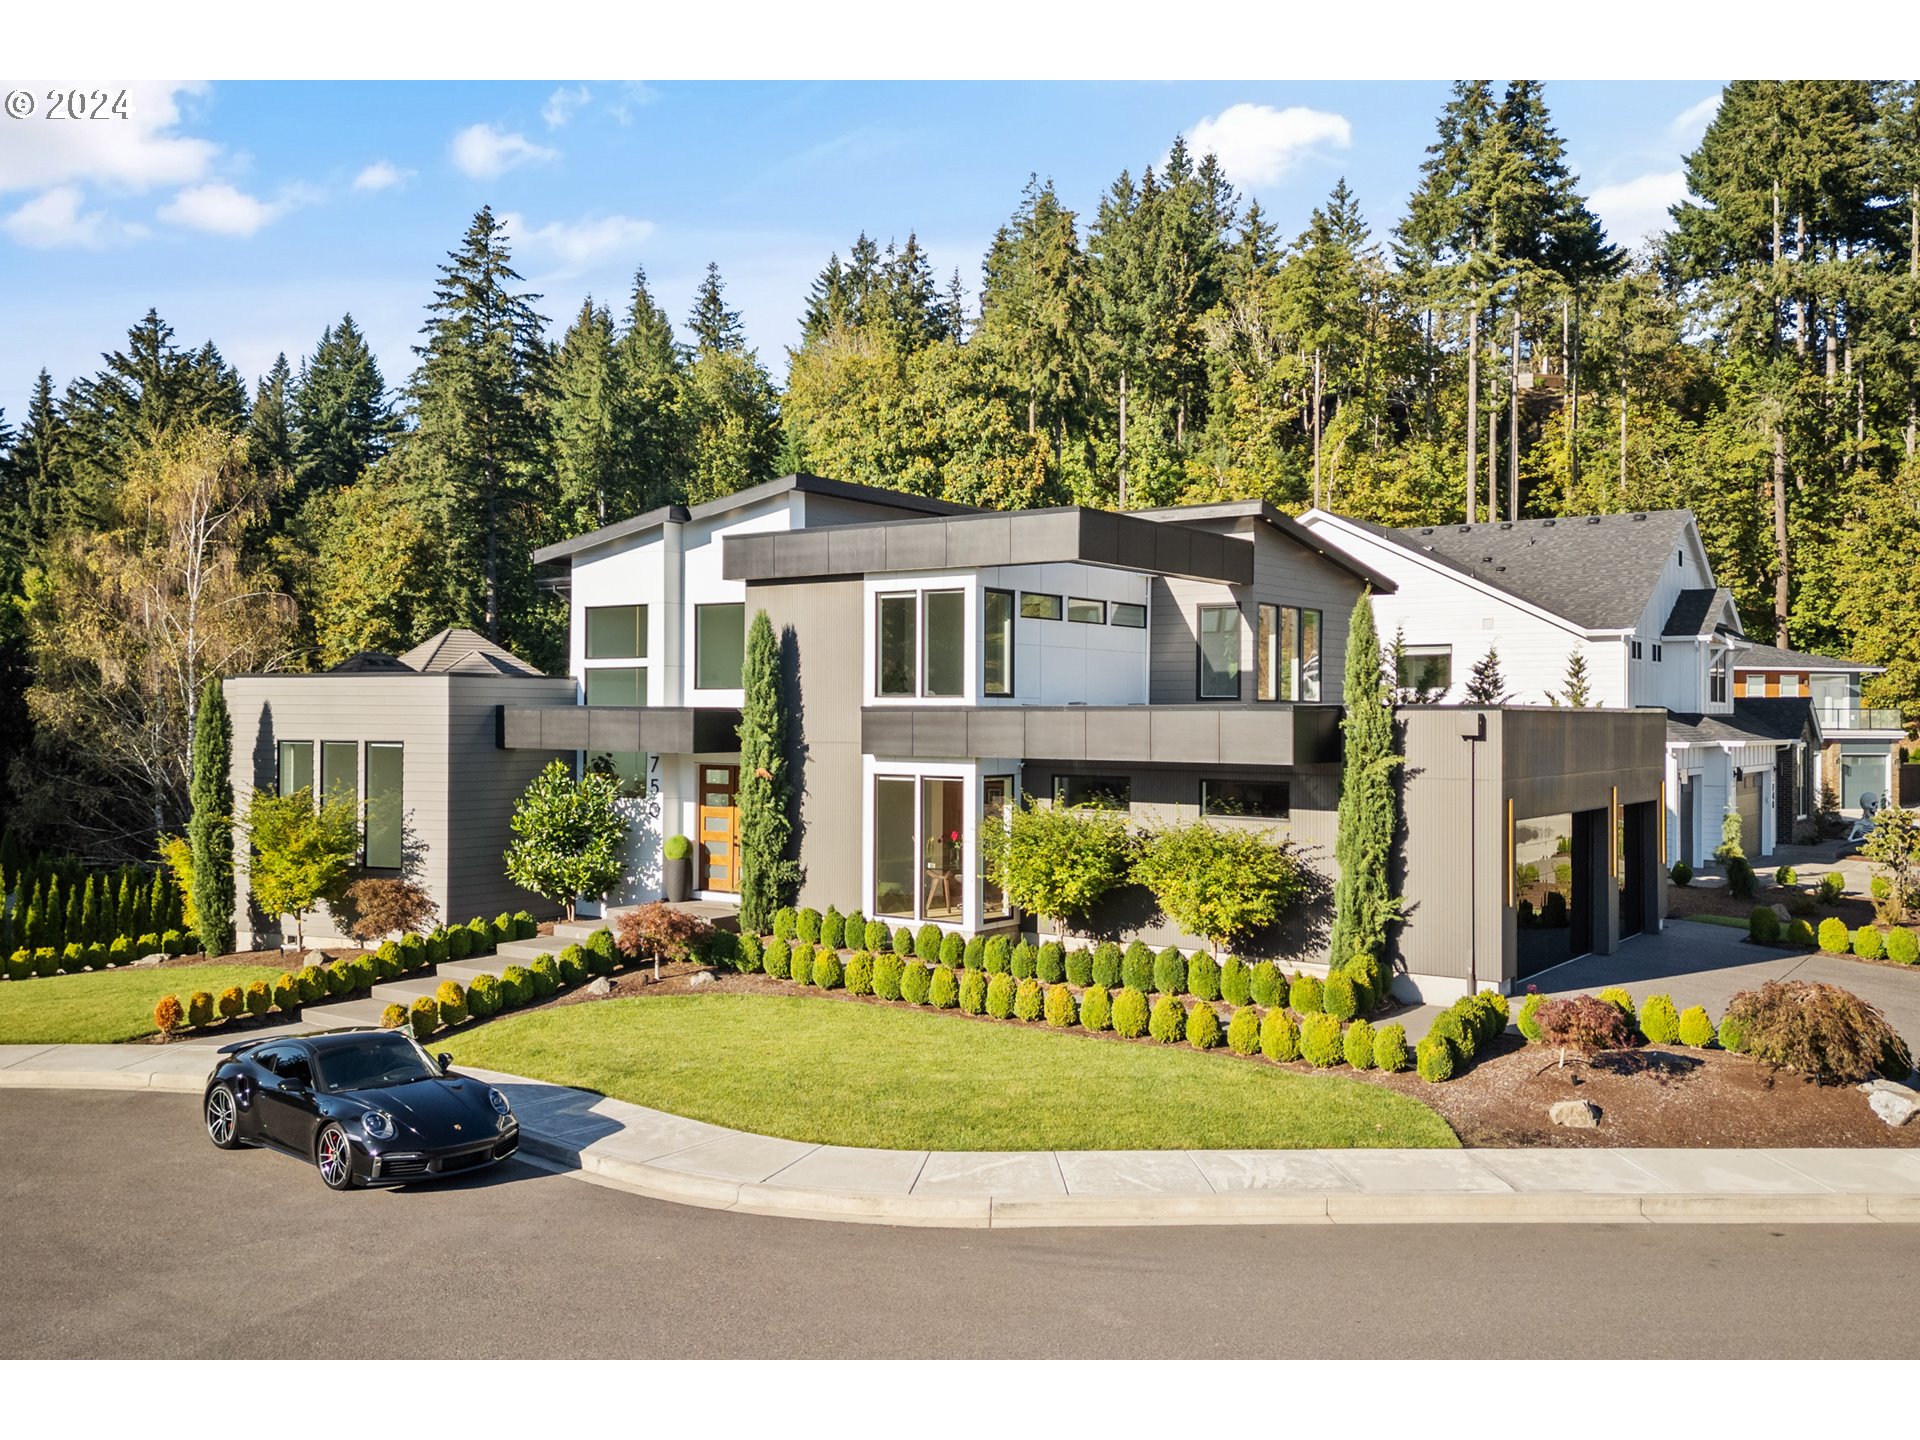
202, 1029, 520, 1190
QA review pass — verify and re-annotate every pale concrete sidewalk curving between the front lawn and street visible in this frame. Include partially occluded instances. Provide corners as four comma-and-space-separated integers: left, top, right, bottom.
0, 1044, 1920, 1229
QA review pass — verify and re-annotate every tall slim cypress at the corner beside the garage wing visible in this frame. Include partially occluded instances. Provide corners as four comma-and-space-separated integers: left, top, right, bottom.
1327, 595, 1400, 968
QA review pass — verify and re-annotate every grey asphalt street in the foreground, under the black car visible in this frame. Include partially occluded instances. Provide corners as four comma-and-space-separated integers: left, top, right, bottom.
0, 1091, 1920, 1359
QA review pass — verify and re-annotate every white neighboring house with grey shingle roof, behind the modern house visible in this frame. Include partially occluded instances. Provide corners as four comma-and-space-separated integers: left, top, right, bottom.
1302, 511, 1822, 866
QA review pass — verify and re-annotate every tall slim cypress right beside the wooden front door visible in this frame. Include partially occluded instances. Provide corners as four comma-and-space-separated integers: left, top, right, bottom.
739, 611, 797, 935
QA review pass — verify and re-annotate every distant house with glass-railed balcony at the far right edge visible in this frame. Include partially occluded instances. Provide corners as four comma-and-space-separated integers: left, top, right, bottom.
1734, 645, 1907, 814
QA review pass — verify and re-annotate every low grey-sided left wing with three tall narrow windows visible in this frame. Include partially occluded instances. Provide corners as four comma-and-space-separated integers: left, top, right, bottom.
227, 630, 574, 950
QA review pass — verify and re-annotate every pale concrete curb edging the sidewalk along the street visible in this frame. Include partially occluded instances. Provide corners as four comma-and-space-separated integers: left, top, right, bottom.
0, 1069, 1920, 1229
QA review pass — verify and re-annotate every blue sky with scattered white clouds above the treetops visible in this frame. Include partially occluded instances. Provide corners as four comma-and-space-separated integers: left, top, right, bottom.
0, 81, 1720, 420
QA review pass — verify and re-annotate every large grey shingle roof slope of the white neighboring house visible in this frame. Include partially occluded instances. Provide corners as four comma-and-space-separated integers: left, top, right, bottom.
1342, 511, 1693, 630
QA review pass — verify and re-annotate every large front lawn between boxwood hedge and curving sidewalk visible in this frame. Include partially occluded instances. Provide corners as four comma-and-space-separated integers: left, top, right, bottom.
449, 995, 1459, 1150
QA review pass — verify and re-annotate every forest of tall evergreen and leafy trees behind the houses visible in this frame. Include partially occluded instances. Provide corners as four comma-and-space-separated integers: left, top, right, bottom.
0, 81, 1920, 860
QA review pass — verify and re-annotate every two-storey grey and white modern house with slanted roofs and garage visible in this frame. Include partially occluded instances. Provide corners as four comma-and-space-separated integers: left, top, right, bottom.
220, 476, 1667, 998
